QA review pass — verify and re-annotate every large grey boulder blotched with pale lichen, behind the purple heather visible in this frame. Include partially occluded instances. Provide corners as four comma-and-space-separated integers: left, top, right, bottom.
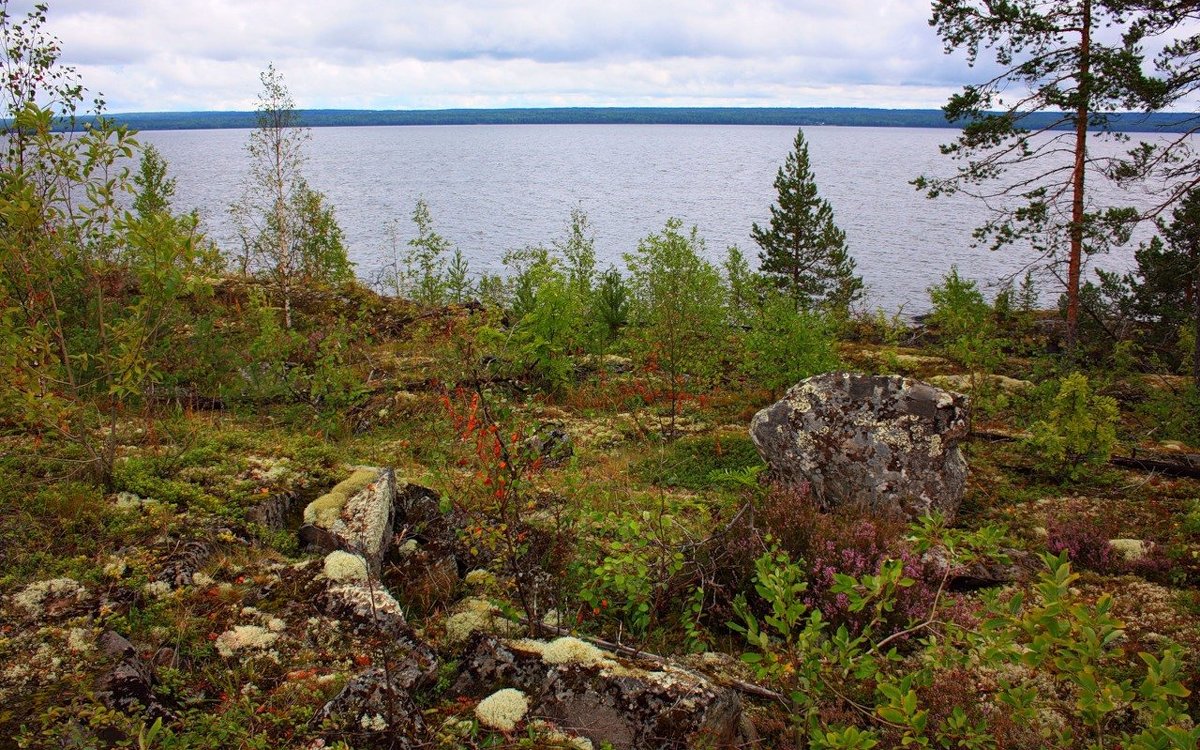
750, 372, 970, 517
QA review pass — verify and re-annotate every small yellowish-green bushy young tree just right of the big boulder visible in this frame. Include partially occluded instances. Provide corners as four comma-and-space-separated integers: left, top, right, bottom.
1024, 372, 1120, 480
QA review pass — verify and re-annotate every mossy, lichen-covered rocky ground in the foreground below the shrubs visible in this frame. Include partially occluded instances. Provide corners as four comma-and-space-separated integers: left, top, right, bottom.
0, 314, 1200, 748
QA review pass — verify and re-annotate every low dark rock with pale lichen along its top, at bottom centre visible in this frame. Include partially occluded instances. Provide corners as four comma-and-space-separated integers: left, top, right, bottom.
454, 635, 745, 750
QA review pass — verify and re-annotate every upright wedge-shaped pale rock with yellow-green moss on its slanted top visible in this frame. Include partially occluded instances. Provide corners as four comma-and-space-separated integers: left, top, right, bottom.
299, 468, 396, 572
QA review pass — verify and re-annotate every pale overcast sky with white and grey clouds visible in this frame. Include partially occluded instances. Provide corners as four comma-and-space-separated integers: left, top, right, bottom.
10, 0, 1190, 112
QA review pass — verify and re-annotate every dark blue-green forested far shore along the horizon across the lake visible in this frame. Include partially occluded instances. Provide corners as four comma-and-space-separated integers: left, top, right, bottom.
96, 107, 1200, 133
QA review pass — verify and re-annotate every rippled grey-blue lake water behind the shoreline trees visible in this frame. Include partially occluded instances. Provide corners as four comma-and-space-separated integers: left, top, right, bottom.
140, 125, 1171, 313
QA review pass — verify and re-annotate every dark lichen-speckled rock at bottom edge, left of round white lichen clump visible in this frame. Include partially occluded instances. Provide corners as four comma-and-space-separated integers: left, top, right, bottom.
310, 666, 426, 749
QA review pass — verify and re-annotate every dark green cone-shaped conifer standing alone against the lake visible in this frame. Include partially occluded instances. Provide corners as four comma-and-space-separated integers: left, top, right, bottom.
750, 131, 863, 312
